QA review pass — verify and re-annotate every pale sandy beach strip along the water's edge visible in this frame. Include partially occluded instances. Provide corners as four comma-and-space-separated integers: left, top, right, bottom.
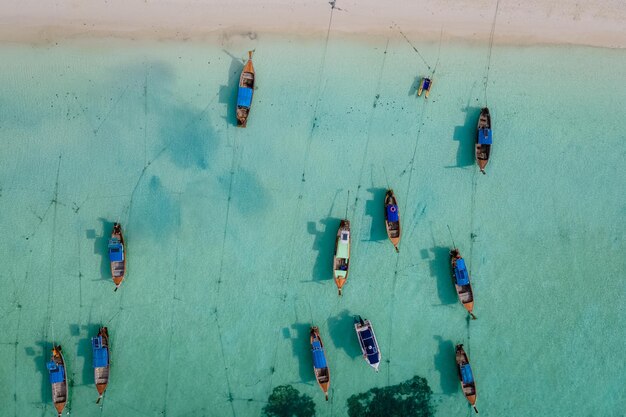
0, 0, 626, 48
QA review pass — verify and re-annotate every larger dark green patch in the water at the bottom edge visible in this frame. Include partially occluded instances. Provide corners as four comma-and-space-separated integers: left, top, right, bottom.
348, 376, 434, 417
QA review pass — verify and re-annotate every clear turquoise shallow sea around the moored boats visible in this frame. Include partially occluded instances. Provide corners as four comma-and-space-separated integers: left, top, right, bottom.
0, 35, 626, 417
